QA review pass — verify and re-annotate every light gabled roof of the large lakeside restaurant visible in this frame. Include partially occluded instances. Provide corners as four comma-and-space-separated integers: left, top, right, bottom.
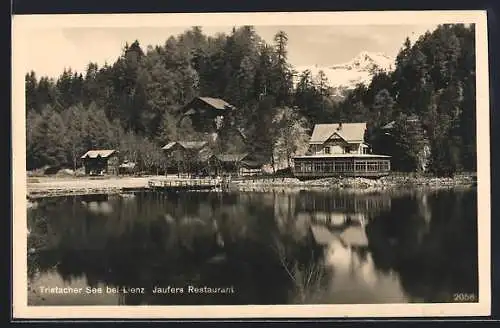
309, 123, 366, 144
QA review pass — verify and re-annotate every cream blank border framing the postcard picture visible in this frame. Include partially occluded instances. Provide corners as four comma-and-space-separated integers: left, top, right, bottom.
12, 10, 491, 319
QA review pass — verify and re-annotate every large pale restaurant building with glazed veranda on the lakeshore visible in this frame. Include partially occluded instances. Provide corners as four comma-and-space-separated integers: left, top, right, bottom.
293, 123, 391, 179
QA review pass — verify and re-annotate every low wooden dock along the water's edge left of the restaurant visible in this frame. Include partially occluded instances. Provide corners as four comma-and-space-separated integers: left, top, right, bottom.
148, 178, 229, 191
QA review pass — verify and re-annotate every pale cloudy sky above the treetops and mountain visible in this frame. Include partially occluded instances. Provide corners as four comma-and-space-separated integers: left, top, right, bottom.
25, 24, 436, 78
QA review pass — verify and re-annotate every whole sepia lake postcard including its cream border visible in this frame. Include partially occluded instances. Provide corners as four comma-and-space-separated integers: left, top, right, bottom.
12, 11, 490, 318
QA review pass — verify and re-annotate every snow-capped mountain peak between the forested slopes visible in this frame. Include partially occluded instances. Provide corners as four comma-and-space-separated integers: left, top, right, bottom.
295, 51, 394, 89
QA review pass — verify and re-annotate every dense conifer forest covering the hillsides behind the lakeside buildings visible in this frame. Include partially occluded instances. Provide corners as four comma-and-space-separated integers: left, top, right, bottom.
25, 24, 476, 175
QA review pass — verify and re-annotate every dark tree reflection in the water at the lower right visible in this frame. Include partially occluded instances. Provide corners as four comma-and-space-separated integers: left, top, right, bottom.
367, 191, 478, 302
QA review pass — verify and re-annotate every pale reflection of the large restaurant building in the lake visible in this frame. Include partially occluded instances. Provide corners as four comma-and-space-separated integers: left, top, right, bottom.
275, 192, 408, 303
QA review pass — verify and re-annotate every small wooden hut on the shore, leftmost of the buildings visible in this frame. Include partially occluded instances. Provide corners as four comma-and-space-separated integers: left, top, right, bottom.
81, 149, 119, 175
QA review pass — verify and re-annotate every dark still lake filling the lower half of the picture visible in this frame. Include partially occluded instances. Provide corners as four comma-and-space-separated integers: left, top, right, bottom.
28, 189, 478, 305
